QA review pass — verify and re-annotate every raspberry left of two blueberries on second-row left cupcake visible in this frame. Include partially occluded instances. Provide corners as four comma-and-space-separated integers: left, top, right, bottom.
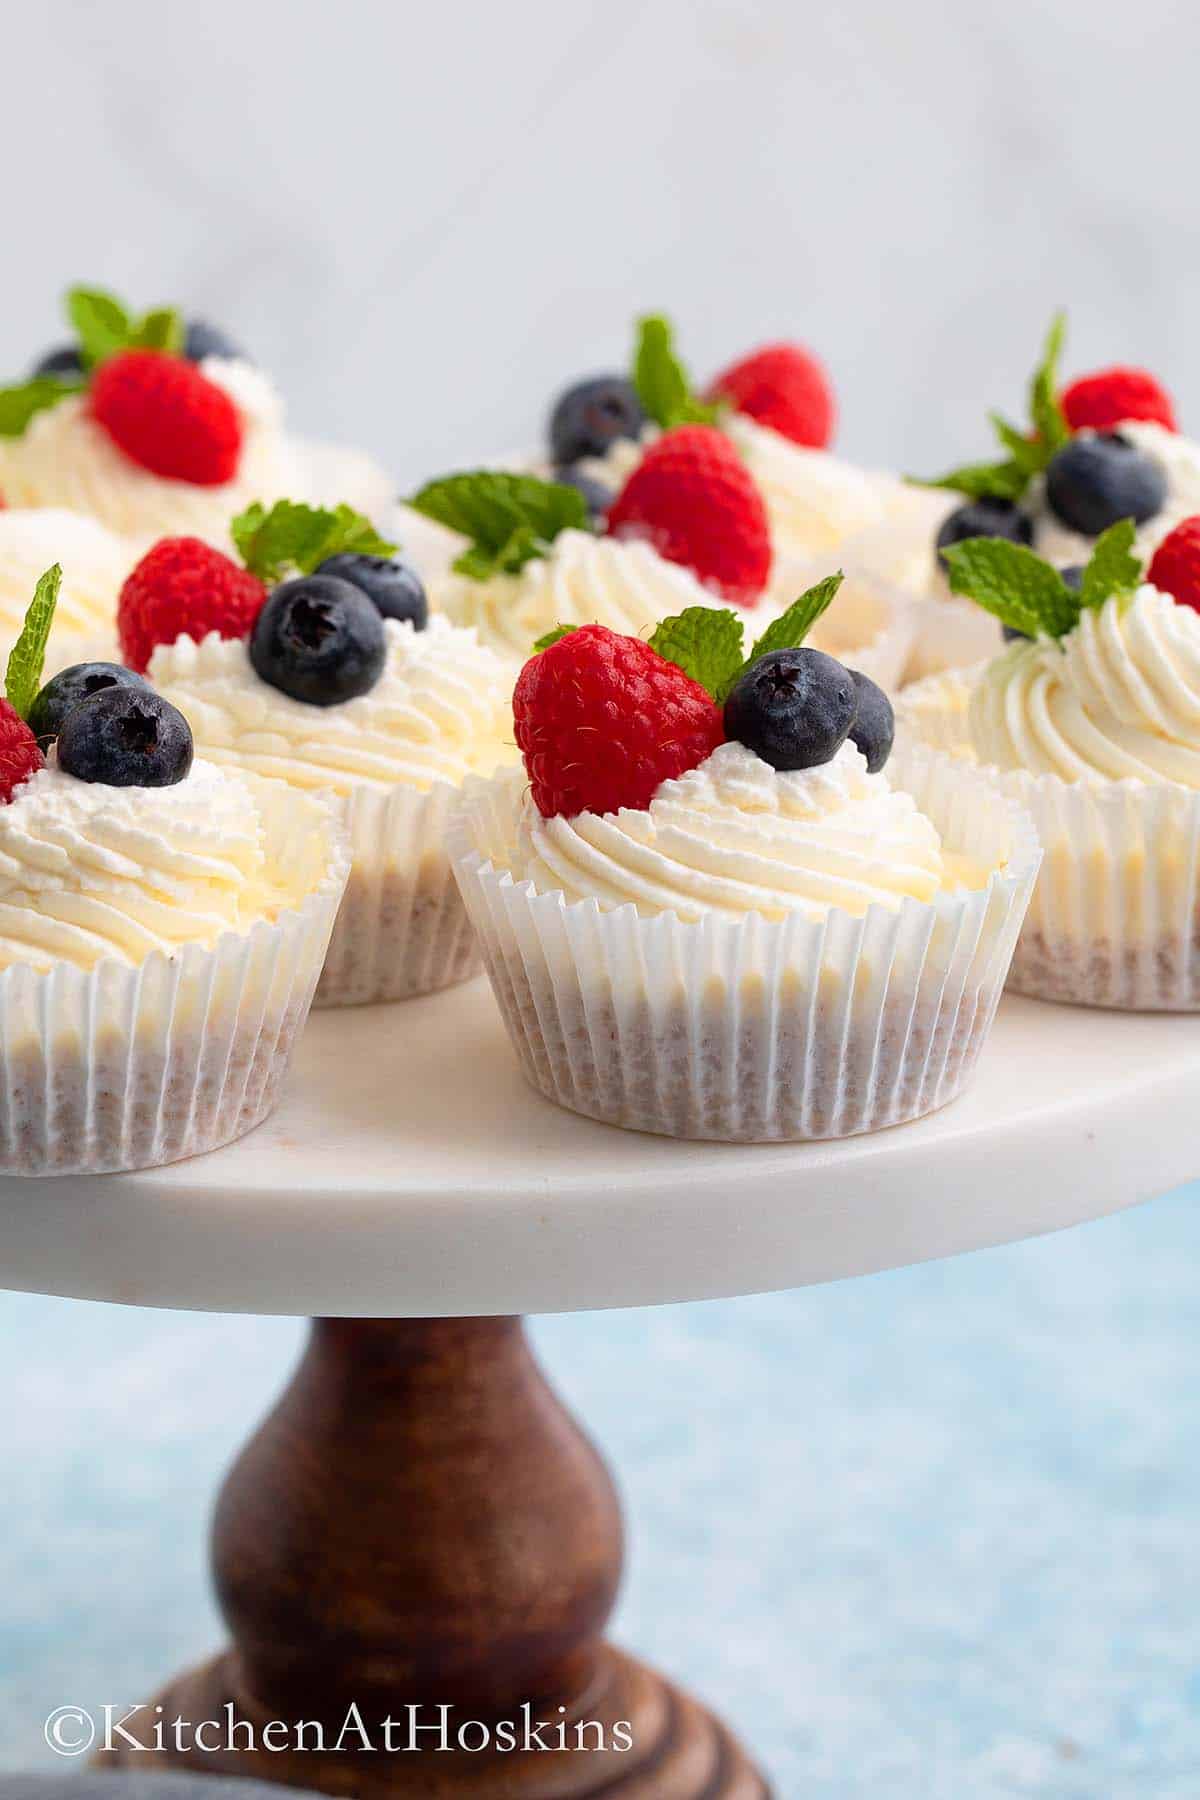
117, 538, 266, 675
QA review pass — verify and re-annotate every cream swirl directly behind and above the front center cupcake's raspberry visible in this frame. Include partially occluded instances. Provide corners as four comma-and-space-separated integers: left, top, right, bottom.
432, 531, 734, 662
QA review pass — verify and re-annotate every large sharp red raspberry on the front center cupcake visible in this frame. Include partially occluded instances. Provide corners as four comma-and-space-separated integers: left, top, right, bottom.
513, 625, 725, 819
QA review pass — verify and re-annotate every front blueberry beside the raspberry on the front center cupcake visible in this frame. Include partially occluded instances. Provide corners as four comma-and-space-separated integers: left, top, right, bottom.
725, 648, 858, 769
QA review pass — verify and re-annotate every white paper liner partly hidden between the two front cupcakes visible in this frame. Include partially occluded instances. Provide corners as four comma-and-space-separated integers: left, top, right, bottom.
313, 781, 480, 1006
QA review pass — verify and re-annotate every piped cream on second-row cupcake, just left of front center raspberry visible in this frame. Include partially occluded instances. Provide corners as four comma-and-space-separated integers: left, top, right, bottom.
149, 617, 515, 794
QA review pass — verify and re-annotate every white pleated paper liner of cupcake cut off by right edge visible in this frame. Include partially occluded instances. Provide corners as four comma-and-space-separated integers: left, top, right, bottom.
900, 670, 1200, 1012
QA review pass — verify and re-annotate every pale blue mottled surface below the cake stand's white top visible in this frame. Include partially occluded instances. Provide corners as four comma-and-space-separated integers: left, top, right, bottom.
0, 1188, 1200, 1800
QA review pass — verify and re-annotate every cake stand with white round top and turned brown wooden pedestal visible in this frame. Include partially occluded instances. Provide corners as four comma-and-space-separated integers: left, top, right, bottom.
0, 983, 1200, 1800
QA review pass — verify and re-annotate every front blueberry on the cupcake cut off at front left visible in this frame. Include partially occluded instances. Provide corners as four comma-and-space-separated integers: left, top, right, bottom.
58, 684, 193, 787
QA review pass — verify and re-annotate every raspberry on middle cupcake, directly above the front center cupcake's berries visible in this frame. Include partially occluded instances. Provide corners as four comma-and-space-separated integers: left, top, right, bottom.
608, 425, 770, 607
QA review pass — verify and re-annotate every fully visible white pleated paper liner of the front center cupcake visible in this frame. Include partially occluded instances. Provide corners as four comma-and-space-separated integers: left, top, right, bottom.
450, 751, 1040, 1141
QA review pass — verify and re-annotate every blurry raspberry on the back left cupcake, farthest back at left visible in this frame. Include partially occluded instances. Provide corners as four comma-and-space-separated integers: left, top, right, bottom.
90, 349, 241, 488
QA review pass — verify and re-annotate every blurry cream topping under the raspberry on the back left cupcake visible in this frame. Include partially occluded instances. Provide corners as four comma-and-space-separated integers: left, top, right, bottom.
0, 356, 299, 547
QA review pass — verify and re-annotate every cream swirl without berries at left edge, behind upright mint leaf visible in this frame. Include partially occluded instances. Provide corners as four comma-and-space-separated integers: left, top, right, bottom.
0, 506, 137, 650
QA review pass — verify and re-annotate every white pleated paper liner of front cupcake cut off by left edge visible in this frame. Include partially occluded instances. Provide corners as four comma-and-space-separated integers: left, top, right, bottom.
0, 783, 349, 1175
